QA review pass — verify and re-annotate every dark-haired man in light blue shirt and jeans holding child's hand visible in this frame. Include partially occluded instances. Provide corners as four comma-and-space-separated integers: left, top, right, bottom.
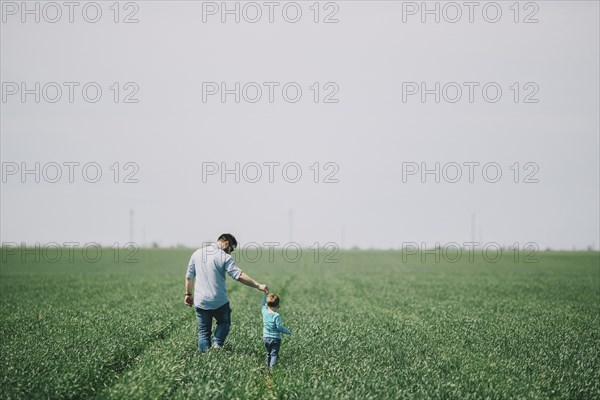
185, 233, 269, 352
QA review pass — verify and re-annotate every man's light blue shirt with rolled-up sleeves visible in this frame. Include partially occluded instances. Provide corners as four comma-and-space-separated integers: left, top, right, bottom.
185, 243, 242, 310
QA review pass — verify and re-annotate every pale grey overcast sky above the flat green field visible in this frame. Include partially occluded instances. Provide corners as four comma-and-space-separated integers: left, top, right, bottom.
0, 1, 600, 249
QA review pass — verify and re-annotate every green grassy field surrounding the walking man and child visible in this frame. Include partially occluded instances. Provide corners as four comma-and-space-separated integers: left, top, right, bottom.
0, 249, 600, 399
